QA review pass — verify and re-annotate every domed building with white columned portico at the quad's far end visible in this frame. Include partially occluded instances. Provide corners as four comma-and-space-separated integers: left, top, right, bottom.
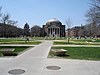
43, 18, 65, 37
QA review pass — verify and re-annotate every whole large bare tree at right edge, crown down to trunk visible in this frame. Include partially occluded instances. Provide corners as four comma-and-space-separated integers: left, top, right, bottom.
86, 0, 100, 36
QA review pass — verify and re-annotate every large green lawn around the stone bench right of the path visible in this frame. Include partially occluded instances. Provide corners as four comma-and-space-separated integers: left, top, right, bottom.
50, 47, 100, 60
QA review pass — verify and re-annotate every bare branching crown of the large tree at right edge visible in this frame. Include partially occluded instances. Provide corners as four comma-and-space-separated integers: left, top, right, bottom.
86, 0, 100, 25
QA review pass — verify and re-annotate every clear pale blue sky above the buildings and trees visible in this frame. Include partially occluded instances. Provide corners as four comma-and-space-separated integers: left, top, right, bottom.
0, 0, 90, 28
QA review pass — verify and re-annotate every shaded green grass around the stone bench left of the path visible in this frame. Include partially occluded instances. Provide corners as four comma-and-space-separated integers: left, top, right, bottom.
0, 46, 30, 56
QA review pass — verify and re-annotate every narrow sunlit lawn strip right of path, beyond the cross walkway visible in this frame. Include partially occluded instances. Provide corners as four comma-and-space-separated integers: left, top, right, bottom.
53, 39, 100, 45
